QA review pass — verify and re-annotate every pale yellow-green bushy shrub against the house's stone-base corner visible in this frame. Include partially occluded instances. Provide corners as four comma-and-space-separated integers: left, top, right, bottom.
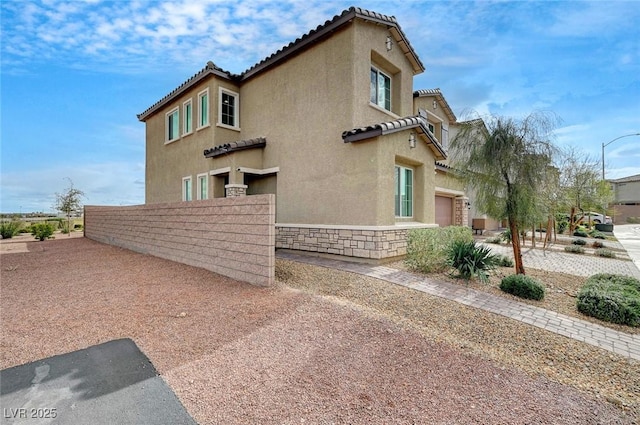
405, 226, 473, 273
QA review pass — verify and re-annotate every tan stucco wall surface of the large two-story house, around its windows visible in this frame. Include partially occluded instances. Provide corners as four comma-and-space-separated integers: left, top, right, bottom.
146, 19, 435, 226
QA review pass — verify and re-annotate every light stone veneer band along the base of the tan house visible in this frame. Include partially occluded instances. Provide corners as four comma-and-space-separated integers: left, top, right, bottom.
276, 224, 437, 259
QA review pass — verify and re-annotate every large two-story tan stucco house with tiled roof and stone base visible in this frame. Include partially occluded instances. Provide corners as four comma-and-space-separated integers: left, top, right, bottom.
138, 8, 468, 258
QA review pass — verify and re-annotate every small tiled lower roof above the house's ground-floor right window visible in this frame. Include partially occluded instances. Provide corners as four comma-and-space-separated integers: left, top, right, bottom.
342, 115, 447, 159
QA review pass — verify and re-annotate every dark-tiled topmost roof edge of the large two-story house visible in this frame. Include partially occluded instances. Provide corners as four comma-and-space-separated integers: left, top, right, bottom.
138, 7, 425, 121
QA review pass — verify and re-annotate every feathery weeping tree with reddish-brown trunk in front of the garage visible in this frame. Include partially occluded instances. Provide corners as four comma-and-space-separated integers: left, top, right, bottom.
451, 113, 556, 274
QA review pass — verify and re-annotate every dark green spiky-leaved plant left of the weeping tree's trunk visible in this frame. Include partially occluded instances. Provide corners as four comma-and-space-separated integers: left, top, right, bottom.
447, 240, 499, 281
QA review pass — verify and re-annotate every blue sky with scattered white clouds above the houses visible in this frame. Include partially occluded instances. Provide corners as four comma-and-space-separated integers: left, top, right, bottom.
0, 0, 640, 212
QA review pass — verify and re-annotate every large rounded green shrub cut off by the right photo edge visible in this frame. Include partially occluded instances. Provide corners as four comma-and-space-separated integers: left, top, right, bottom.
577, 273, 640, 326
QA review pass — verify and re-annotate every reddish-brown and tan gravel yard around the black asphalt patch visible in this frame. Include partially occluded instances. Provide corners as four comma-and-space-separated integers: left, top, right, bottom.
0, 237, 640, 424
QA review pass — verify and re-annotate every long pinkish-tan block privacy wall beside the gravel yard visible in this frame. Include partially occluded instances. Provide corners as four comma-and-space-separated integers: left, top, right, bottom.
84, 195, 276, 286
